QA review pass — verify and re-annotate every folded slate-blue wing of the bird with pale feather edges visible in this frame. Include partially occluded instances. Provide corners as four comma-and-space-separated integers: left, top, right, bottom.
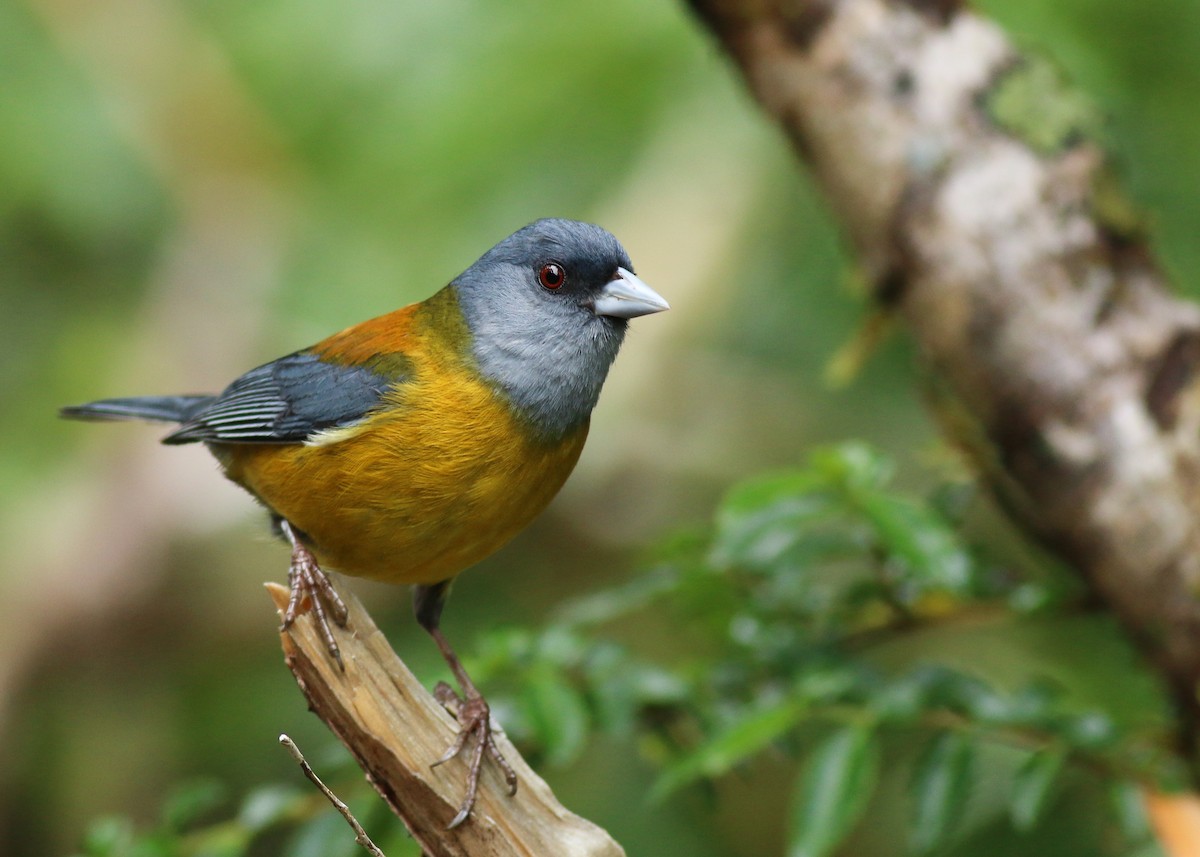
163, 350, 404, 444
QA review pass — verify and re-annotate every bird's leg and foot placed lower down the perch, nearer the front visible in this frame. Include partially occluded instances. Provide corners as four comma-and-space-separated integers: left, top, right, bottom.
413, 582, 517, 829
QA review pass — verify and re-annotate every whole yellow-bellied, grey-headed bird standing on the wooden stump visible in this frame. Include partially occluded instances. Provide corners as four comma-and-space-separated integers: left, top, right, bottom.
60, 218, 670, 827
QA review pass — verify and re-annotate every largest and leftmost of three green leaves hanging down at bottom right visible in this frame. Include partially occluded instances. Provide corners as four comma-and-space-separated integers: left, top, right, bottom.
787, 726, 880, 857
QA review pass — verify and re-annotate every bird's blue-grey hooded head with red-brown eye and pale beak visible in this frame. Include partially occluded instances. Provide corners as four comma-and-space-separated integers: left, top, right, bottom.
450, 220, 667, 439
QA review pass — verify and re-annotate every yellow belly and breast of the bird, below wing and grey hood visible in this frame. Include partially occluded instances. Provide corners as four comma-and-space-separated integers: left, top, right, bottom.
214, 364, 587, 583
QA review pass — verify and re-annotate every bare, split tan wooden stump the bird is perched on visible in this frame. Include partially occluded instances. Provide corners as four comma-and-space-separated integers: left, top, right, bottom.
266, 583, 625, 857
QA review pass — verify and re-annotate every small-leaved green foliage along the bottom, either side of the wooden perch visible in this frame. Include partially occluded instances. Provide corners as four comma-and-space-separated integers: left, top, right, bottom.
72, 443, 1178, 857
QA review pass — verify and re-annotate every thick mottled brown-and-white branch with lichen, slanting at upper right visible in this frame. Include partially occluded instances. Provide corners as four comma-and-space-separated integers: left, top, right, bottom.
691, 0, 1200, 763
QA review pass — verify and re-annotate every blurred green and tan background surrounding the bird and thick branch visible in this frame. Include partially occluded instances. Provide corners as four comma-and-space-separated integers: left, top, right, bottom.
0, 0, 1200, 857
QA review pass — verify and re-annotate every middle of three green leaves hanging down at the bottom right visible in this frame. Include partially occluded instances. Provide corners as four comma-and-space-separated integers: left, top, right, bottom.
908, 731, 976, 855
